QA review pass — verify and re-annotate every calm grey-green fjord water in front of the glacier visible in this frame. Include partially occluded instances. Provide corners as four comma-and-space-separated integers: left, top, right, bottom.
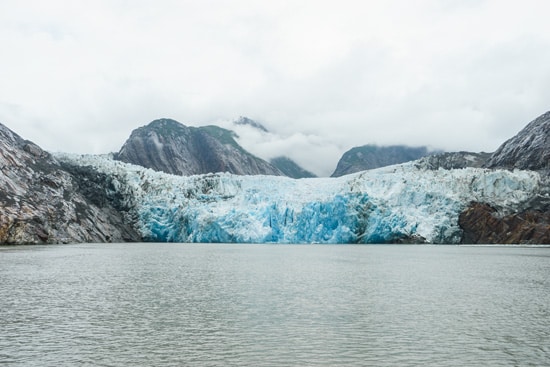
0, 244, 550, 366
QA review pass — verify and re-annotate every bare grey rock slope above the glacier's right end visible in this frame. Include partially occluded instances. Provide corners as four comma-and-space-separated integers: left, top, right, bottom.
486, 111, 550, 173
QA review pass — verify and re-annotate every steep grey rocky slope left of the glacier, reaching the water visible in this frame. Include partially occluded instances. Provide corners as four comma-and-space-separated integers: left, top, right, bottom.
0, 124, 141, 244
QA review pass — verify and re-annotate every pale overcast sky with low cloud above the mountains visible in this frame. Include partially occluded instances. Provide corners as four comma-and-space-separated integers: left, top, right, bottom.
0, 0, 550, 175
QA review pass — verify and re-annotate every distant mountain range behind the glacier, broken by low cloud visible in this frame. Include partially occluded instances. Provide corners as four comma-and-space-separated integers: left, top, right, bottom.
115, 117, 448, 178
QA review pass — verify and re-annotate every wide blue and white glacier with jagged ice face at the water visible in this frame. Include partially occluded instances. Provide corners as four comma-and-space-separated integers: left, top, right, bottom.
55, 153, 541, 244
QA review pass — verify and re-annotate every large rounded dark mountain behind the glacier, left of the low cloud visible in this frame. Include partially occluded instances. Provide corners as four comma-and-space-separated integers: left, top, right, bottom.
116, 119, 282, 176
